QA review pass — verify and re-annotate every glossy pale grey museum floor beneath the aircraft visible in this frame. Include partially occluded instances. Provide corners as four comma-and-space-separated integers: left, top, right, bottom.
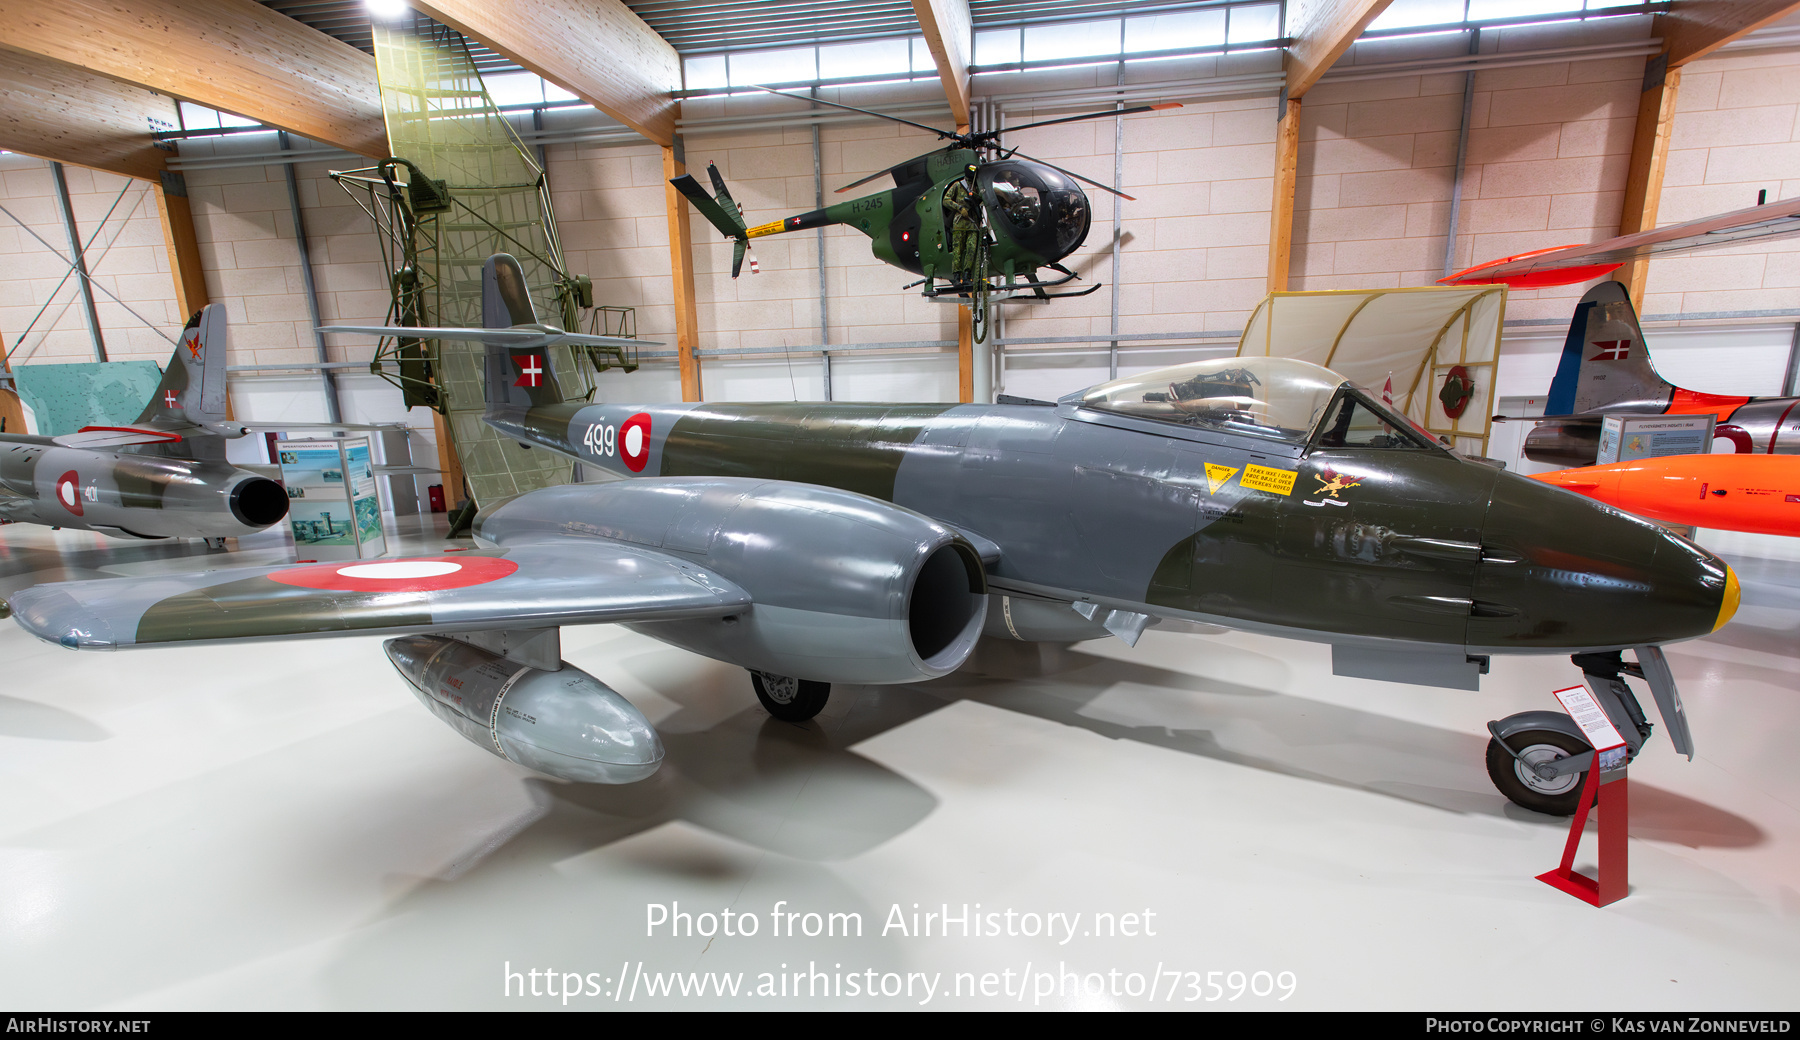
0, 520, 1800, 1009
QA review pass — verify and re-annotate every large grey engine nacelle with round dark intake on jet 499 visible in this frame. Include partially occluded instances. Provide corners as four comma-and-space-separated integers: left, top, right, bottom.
481, 477, 988, 684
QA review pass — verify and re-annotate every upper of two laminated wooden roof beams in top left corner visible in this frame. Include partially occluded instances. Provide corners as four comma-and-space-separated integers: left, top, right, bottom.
0, 0, 387, 158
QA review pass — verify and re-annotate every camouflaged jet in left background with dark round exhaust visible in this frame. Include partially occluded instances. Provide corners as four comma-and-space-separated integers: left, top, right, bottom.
0, 304, 288, 547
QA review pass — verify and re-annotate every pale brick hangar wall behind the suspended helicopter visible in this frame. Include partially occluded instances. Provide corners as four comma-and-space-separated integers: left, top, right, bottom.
0, 20, 1800, 408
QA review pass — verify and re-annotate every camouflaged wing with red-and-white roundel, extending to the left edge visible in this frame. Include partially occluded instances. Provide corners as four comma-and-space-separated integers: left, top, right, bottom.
11, 538, 751, 650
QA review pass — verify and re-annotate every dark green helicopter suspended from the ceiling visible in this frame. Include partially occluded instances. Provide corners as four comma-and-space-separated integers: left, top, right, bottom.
670, 86, 1181, 342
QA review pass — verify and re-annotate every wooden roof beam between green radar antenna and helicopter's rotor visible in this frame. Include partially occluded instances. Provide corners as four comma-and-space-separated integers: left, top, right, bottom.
408, 0, 682, 146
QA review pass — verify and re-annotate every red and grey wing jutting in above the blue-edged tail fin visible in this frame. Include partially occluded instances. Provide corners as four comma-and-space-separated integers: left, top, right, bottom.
1438, 198, 1800, 288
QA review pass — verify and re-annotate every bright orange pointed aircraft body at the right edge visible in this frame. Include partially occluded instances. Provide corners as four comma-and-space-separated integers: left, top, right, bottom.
1534, 455, 1800, 534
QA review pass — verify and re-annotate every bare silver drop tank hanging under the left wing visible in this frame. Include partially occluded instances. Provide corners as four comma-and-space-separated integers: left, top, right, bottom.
382, 635, 662, 784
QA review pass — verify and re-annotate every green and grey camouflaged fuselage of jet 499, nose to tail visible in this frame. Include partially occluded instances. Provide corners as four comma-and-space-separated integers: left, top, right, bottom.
488, 392, 1728, 653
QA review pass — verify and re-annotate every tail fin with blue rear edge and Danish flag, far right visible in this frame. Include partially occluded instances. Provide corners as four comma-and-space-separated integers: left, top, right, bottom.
1544, 281, 1676, 416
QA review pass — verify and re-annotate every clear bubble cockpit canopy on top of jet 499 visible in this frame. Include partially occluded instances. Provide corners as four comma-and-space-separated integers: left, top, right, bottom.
1080, 358, 1345, 444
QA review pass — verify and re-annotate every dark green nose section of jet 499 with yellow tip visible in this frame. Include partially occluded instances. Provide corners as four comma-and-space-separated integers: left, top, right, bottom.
1469, 473, 1739, 653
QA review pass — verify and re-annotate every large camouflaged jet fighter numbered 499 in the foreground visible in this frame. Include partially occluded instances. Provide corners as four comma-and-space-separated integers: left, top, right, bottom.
13, 256, 1737, 813
